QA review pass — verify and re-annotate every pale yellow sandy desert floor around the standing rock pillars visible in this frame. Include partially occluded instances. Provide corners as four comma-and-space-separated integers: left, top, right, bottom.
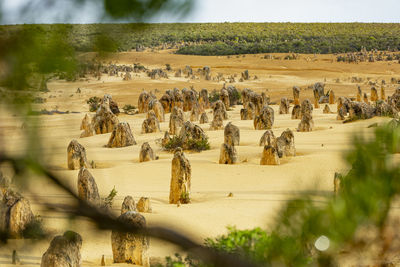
0, 52, 400, 266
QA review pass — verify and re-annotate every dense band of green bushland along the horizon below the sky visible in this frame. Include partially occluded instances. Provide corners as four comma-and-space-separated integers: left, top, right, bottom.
0, 23, 400, 55
